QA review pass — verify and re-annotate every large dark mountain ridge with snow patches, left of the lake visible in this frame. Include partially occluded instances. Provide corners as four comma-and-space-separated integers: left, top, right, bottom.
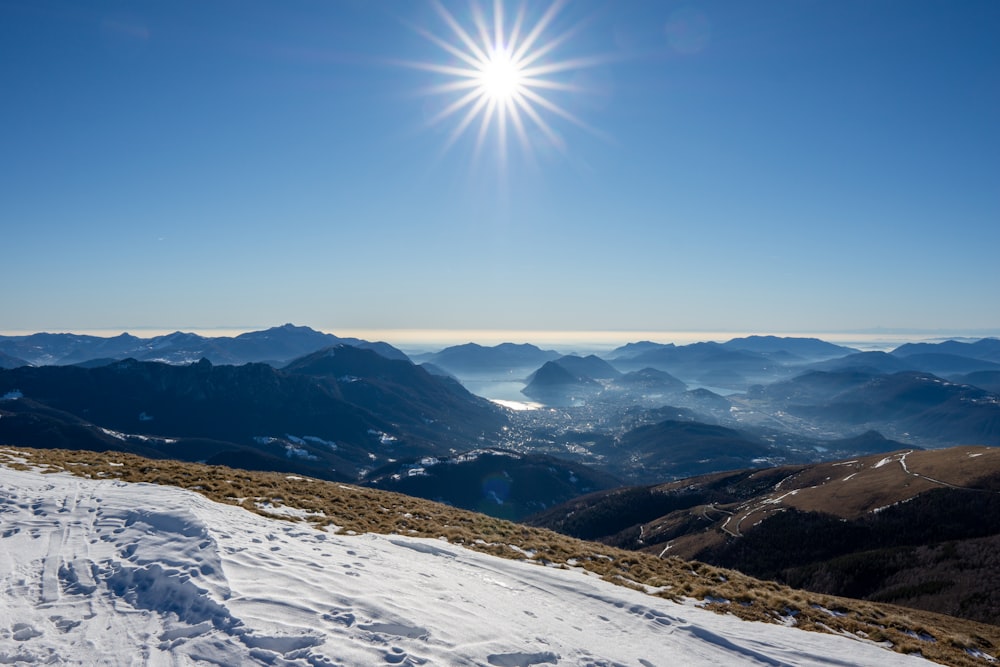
0, 345, 506, 479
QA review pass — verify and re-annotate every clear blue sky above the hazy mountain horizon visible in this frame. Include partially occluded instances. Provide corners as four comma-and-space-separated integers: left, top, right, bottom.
0, 0, 1000, 340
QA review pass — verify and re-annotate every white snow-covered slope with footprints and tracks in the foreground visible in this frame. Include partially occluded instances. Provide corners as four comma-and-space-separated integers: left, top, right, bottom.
0, 467, 927, 667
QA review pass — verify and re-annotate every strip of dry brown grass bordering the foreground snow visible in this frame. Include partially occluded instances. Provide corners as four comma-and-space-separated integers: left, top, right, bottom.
0, 448, 1000, 667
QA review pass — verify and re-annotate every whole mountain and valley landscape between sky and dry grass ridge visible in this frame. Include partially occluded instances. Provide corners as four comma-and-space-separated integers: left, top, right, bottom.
0, 325, 1000, 644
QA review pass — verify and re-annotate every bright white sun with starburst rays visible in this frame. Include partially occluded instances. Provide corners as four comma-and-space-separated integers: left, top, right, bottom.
401, 0, 608, 163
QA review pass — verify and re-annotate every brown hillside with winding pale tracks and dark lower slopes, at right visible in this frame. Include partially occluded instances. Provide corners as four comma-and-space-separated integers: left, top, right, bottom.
530, 447, 1000, 623
